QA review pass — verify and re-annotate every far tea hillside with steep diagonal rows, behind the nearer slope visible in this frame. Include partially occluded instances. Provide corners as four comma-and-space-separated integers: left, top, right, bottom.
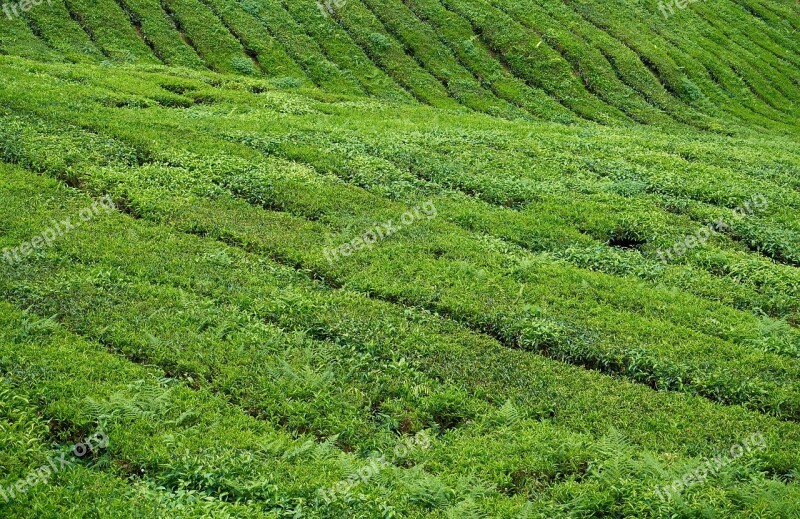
0, 0, 800, 132
